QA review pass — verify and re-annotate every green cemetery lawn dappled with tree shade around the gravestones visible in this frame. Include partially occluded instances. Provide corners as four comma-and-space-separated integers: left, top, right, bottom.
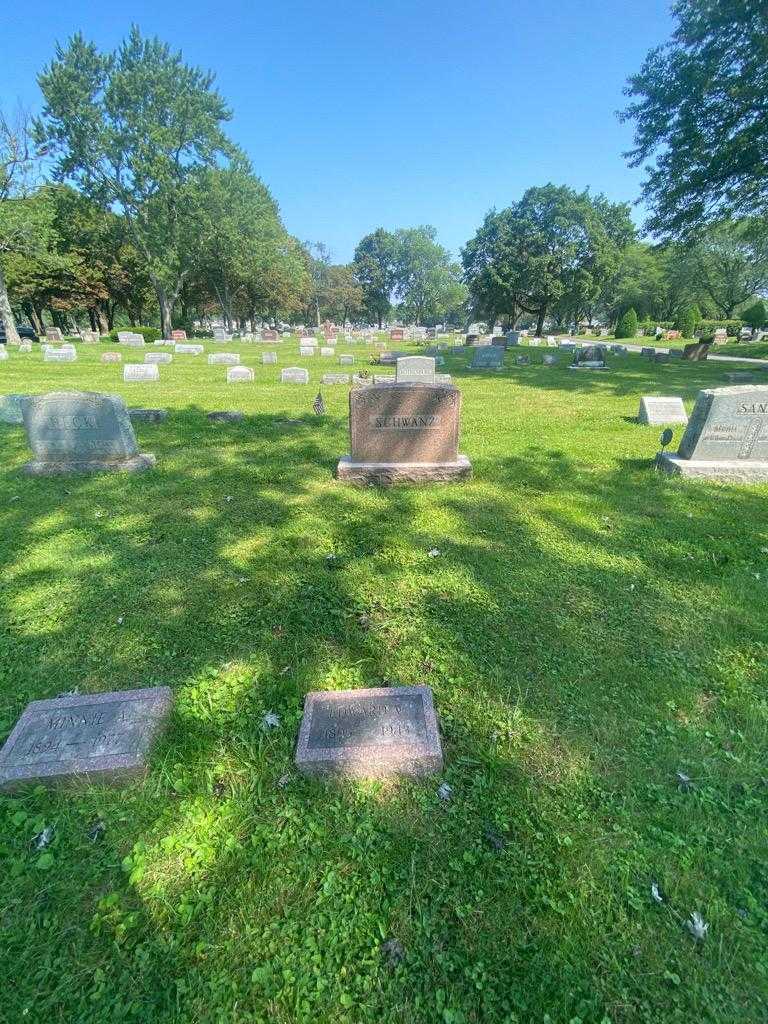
0, 342, 768, 1024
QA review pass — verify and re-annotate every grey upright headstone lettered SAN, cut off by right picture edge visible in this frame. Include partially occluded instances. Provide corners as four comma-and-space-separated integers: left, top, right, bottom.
656, 385, 768, 483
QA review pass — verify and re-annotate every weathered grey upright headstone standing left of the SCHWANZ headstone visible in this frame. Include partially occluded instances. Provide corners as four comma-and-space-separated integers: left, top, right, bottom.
22, 391, 156, 476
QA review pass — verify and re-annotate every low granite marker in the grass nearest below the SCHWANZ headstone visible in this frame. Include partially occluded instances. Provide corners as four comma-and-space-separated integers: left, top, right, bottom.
296, 686, 442, 778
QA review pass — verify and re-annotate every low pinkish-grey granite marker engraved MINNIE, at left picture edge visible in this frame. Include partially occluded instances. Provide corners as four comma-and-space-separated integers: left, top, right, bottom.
0, 686, 173, 792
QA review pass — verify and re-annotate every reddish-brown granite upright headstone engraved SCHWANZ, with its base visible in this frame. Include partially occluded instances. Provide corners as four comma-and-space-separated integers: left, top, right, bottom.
336, 381, 472, 484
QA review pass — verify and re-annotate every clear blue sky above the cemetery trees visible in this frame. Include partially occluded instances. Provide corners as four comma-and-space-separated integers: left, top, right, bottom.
0, 0, 672, 261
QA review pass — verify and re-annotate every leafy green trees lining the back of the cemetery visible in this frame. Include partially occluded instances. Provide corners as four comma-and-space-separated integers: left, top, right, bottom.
0, 0, 768, 339
